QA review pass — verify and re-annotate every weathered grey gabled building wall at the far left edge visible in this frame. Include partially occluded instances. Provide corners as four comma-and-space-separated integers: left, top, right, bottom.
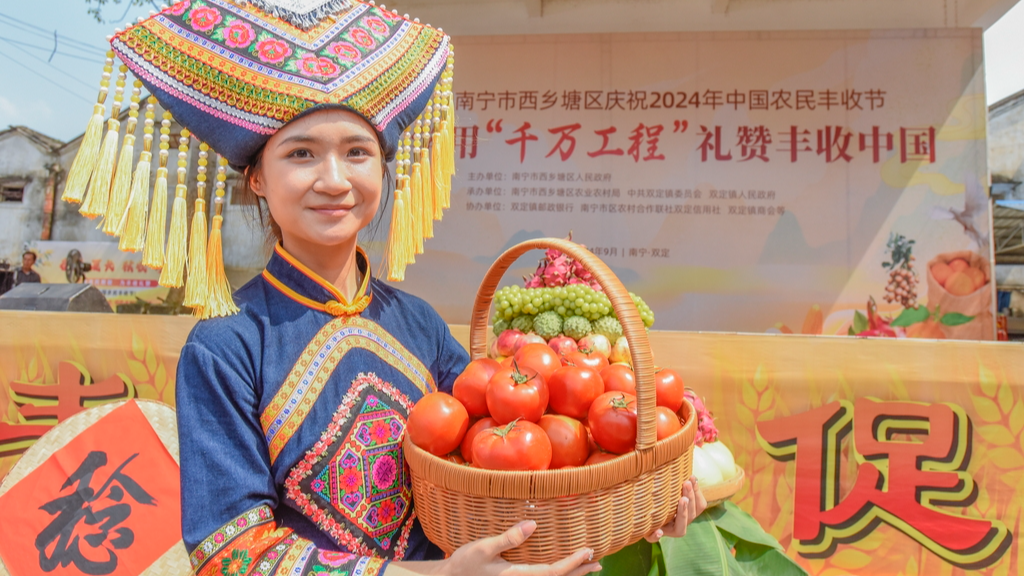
0, 131, 54, 265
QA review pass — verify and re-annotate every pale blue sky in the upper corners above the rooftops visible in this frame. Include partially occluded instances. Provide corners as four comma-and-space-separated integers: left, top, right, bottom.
0, 0, 1024, 139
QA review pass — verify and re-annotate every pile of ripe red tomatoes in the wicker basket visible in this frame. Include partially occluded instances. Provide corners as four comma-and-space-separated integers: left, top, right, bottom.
409, 343, 685, 470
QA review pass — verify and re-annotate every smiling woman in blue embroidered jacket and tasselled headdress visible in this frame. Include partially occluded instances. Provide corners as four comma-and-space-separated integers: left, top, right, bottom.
59, 0, 705, 576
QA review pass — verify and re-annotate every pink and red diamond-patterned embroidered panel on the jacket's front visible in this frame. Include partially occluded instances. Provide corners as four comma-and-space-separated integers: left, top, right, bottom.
285, 374, 415, 559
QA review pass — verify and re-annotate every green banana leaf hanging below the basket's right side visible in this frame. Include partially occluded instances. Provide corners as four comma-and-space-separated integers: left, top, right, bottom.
601, 502, 807, 576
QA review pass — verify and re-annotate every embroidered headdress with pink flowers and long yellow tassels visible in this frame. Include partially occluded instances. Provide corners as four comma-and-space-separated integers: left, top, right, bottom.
62, 0, 455, 318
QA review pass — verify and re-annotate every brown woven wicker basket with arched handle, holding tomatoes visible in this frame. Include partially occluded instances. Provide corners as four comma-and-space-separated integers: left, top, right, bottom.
404, 238, 696, 564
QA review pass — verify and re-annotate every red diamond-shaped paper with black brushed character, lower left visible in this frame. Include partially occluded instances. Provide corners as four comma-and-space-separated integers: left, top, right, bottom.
0, 401, 181, 576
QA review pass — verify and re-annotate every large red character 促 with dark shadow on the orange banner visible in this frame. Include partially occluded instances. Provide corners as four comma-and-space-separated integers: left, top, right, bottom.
758, 399, 1012, 570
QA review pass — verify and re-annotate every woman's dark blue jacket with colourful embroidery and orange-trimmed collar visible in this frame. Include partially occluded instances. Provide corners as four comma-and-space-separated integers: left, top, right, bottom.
177, 246, 469, 576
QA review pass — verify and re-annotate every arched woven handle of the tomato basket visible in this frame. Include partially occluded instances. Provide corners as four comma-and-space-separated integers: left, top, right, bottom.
469, 238, 657, 451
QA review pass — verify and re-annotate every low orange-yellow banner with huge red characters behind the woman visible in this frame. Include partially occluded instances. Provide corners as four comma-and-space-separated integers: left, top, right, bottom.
0, 312, 1024, 576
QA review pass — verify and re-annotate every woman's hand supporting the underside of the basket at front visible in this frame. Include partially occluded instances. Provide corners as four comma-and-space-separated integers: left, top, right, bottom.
387, 521, 601, 576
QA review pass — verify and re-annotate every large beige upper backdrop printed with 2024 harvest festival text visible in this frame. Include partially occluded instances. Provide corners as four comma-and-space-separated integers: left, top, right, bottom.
397, 30, 994, 339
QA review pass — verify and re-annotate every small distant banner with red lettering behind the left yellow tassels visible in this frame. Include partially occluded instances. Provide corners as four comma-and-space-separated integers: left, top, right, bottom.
31, 241, 168, 306
